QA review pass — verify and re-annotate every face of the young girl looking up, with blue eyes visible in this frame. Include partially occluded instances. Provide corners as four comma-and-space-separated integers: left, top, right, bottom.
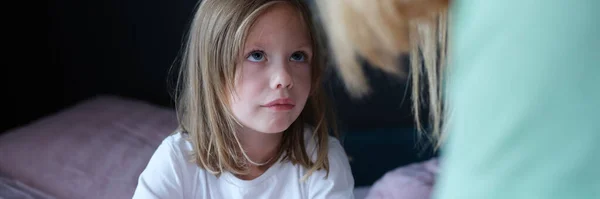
231, 4, 312, 133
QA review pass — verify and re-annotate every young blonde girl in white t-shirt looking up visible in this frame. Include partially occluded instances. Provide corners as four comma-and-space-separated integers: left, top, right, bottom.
133, 0, 354, 199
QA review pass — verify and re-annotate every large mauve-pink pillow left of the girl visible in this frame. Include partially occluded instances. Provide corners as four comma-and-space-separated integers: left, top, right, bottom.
0, 96, 177, 199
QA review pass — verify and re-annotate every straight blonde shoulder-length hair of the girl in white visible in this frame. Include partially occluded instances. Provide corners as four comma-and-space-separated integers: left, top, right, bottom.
176, 0, 337, 177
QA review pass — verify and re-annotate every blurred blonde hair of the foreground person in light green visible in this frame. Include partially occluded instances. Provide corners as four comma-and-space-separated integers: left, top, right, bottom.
317, 0, 449, 148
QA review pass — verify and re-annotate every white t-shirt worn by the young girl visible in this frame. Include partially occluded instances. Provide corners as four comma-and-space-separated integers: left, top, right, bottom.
133, 128, 354, 199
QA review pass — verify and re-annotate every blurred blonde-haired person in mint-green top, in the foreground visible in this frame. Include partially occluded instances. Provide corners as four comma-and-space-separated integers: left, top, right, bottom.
318, 0, 600, 199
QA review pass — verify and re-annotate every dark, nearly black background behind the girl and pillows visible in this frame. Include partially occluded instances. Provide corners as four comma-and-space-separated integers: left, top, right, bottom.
1, 0, 431, 185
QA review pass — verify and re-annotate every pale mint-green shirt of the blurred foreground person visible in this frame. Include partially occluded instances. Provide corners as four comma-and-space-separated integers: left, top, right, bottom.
434, 0, 600, 199
